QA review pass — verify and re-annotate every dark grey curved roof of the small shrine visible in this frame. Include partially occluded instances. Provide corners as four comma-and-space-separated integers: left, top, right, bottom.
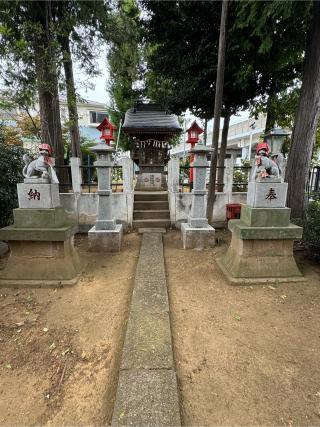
122, 104, 182, 135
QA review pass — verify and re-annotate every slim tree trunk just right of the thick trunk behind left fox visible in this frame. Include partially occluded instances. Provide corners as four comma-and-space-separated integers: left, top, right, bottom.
60, 36, 82, 159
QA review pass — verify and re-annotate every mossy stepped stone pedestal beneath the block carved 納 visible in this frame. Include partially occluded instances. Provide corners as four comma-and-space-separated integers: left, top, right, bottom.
0, 207, 81, 287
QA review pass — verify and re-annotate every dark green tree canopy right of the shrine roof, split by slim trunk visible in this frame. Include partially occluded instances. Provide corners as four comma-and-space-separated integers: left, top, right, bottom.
142, 0, 312, 118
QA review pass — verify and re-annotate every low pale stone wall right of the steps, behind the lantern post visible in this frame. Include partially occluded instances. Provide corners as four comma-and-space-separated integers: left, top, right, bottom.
168, 191, 247, 228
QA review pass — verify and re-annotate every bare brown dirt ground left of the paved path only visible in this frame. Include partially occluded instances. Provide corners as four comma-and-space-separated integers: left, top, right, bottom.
0, 234, 140, 426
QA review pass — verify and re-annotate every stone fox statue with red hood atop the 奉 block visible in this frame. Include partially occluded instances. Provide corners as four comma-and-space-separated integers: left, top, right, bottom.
252, 142, 280, 180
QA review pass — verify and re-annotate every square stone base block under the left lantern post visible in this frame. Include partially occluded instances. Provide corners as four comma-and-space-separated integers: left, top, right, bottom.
88, 224, 123, 252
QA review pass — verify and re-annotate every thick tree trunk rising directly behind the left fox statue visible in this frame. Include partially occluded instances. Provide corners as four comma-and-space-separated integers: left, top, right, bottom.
34, 1, 68, 184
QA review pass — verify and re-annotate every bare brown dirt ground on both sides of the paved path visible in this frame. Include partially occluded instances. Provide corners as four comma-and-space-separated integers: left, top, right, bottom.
0, 231, 320, 426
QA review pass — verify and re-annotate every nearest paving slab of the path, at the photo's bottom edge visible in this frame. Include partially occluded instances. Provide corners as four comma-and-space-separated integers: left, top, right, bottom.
112, 370, 181, 426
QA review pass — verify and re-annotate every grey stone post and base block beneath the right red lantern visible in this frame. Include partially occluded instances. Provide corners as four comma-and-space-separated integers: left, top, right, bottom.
181, 142, 215, 250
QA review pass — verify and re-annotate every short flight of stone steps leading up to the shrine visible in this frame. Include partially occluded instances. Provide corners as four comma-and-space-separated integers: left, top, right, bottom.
133, 191, 171, 229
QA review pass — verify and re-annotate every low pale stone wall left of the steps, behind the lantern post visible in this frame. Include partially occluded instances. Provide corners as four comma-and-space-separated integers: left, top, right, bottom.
60, 193, 133, 233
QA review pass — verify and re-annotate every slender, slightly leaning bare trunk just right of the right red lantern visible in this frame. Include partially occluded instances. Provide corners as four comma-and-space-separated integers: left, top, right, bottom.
207, 0, 228, 223
